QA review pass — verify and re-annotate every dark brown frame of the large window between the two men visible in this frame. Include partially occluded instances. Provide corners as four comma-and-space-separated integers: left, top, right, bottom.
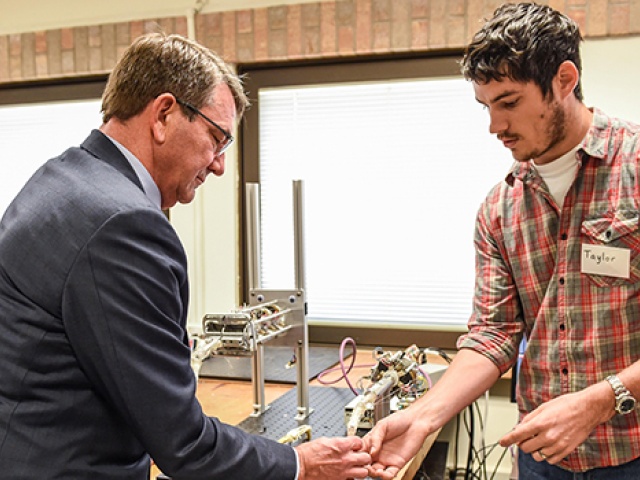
237, 53, 463, 350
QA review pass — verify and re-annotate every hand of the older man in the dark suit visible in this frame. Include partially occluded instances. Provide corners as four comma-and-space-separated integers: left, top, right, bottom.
296, 437, 371, 480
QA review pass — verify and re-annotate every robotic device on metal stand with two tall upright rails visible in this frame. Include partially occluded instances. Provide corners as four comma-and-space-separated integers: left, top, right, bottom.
191, 180, 312, 423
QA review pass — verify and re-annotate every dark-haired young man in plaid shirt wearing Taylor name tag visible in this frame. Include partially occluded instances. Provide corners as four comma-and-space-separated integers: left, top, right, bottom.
365, 3, 640, 480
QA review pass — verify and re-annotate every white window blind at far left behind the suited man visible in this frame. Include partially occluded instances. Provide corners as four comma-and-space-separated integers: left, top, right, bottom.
0, 100, 102, 216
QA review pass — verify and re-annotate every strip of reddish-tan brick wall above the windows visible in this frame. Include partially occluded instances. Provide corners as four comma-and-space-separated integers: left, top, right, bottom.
0, 0, 640, 85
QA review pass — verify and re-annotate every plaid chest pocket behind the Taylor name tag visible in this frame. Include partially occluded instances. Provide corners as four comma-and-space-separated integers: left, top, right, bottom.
581, 211, 640, 287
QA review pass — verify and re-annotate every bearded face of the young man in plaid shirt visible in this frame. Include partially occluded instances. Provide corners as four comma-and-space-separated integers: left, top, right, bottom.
473, 78, 567, 165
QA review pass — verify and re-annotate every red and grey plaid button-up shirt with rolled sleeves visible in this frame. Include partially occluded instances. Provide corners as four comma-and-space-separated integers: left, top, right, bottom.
458, 109, 640, 472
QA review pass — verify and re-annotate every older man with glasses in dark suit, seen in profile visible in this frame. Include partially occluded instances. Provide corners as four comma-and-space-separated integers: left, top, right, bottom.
0, 34, 370, 480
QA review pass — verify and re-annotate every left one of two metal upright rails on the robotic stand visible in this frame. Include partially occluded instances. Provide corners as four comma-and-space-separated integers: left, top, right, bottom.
245, 183, 269, 417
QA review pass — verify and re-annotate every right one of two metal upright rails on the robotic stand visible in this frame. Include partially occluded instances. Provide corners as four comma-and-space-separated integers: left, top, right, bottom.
293, 180, 311, 422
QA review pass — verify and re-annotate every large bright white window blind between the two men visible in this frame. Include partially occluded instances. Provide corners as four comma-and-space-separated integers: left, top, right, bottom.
258, 77, 512, 329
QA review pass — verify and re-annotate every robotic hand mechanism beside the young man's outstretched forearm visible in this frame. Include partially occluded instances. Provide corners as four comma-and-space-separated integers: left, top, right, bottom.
344, 345, 447, 435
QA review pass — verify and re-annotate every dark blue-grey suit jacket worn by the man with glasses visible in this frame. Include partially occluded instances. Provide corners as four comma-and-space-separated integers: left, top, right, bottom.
0, 131, 296, 480
